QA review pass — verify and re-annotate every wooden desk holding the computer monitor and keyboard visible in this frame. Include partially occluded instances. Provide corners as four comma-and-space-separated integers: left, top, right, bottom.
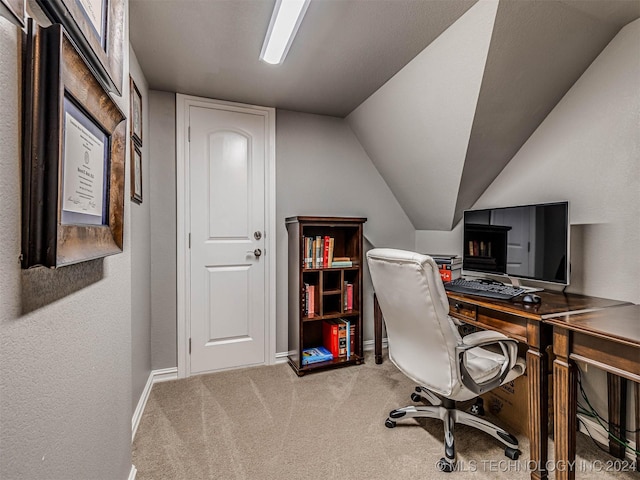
374, 291, 628, 480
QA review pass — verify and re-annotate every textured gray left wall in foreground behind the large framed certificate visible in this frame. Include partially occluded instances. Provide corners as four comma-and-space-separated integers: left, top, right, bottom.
0, 14, 132, 480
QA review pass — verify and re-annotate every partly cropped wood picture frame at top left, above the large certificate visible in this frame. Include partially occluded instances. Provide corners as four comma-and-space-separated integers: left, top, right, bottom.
36, 0, 125, 95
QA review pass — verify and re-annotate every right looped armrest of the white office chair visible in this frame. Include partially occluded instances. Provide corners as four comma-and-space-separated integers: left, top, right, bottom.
456, 330, 518, 395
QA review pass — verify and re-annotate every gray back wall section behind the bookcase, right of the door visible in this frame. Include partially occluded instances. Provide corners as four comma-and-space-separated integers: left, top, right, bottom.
276, 110, 415, 346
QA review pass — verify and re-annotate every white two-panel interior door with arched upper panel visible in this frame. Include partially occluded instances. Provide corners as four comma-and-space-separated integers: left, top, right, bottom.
188, 105, 268, 373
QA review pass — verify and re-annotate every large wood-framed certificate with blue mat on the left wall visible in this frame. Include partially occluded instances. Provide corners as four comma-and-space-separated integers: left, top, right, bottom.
22, 20, 126, 268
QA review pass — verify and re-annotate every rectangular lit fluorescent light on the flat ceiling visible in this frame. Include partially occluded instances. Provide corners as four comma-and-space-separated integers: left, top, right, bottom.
260, 0, 309, 65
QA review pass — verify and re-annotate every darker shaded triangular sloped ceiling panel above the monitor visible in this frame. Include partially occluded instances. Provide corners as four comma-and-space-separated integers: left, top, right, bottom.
452, 1, 640, 225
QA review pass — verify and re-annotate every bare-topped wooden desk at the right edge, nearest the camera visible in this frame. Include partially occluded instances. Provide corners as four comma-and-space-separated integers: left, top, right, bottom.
545, 305, 640, 480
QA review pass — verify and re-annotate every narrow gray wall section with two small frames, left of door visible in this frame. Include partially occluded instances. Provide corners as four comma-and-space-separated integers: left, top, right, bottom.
127, 47, 151, 410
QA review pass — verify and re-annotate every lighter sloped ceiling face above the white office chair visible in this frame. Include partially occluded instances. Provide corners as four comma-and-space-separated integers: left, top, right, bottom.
347, 0, 498, 230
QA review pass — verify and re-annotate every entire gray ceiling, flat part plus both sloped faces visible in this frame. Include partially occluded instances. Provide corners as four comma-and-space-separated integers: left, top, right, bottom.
129, 0, 640, 230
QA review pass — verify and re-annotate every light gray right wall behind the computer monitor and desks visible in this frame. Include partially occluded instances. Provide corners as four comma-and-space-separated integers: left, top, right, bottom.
416, 20, 640, 429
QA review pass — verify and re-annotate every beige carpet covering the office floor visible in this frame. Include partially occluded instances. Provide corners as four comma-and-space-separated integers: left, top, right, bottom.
133, 355, 638, 480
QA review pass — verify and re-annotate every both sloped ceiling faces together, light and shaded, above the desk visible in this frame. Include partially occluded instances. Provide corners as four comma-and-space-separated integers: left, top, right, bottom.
348, 0, 640, 230
